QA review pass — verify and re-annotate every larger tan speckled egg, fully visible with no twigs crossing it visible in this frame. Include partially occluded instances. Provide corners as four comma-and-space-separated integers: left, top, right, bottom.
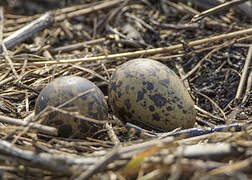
109, 59, 196, 131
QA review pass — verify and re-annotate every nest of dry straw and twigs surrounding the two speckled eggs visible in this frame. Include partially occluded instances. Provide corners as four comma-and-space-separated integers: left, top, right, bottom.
0, 0, 252, 179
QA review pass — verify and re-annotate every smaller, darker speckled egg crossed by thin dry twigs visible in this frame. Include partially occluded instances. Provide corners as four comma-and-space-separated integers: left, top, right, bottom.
35, 76, 108, 138
